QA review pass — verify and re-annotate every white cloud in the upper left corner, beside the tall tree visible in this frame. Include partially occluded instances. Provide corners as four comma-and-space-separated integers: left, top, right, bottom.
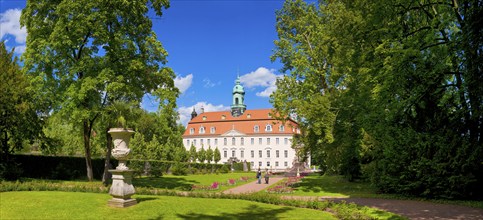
0, 8, 27, 44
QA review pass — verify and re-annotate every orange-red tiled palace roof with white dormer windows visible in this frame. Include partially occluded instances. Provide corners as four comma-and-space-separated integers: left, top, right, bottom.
183, 109, 298, 137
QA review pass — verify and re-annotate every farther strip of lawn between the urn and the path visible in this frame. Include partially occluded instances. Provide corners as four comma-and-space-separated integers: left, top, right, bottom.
133, 173, 255, 191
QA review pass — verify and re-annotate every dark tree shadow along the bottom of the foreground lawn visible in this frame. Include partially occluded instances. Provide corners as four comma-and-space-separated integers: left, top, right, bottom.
174, 205, 294, 220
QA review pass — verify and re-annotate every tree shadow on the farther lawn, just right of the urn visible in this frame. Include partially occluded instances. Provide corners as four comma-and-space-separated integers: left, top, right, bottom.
132, 177, 199, 190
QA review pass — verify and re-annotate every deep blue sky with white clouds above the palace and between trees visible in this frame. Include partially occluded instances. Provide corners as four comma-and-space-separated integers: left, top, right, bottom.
0, 0, 283, 124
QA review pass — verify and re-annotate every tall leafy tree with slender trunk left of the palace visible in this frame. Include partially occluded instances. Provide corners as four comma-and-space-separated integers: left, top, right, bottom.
20, 0, 179, 180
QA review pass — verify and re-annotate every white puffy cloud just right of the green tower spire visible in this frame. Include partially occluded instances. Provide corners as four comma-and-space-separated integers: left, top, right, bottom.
240, 67, 281, 97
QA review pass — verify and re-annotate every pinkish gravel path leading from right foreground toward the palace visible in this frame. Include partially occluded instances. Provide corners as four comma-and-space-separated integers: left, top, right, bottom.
223, 180, 483, 220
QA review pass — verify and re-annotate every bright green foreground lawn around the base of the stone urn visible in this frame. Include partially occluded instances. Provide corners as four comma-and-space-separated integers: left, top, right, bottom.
0, 191, 335, 219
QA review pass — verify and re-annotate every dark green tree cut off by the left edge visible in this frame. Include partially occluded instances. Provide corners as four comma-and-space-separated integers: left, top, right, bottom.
0, 41, 43, 178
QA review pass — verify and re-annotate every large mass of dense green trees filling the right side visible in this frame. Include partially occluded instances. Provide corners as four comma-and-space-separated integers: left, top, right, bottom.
271, 0, 483, 198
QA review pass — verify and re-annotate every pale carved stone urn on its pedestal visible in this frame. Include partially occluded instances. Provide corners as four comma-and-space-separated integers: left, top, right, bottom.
108, 128, 137, 207
